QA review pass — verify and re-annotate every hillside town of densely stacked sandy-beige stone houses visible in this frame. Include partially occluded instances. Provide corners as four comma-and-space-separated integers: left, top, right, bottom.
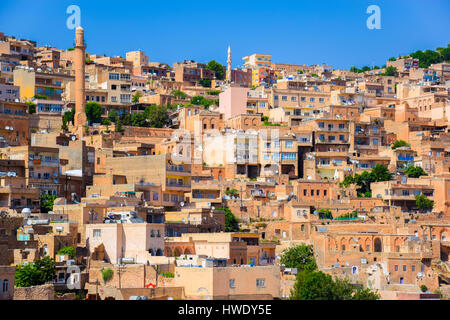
0, 27, 450, 300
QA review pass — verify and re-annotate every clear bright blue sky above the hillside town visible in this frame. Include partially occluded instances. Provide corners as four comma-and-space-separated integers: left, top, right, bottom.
0, 0, 450, 68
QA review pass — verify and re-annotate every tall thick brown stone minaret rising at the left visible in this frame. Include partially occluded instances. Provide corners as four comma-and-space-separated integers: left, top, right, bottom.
74, 27, 87, 135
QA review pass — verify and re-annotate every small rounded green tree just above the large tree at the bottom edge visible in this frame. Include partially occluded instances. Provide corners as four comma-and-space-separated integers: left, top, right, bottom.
280, 244, 317, 271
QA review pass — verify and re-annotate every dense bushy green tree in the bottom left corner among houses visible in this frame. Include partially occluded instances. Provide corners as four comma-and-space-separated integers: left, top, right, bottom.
14, 256, 56, 288
